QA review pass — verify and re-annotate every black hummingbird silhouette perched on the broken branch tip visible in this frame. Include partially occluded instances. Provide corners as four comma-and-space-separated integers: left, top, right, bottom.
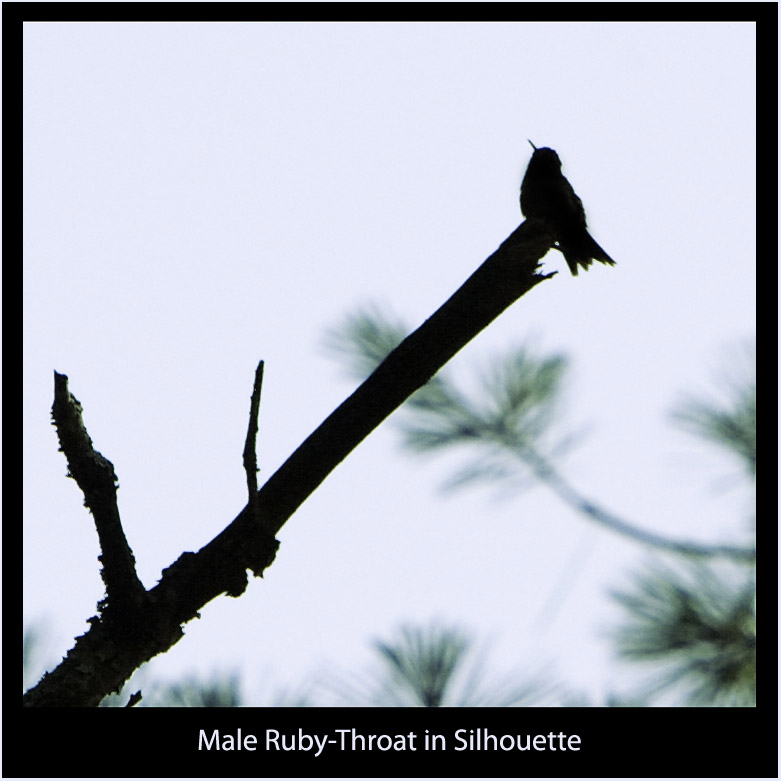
521, 141, 616, 277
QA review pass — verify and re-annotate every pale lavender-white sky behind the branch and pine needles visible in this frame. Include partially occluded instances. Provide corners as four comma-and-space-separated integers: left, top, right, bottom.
24, 23, 756, 702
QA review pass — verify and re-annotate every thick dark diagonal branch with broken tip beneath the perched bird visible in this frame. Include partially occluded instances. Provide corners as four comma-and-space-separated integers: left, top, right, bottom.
24, 220, 555, 707
